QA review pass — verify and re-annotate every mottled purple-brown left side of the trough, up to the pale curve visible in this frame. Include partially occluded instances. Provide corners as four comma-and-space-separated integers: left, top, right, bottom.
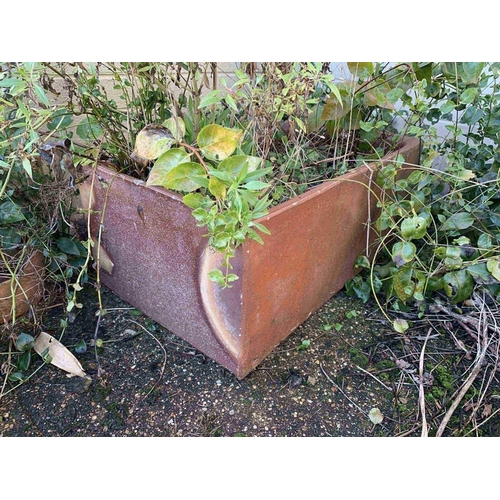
80, 167, 240, 373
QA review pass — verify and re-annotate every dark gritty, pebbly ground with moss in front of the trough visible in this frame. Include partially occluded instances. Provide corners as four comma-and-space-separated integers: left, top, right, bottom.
0, 287, 496, 437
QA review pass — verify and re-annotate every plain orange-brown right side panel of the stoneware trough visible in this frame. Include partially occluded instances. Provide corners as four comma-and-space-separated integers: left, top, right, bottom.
241, 140, 419, 371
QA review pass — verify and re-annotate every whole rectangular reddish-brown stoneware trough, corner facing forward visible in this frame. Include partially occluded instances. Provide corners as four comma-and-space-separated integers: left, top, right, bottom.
80, 139, 420, 379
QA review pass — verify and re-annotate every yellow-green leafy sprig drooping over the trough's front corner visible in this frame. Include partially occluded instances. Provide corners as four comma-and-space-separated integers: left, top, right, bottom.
134, 118, 269, 288
